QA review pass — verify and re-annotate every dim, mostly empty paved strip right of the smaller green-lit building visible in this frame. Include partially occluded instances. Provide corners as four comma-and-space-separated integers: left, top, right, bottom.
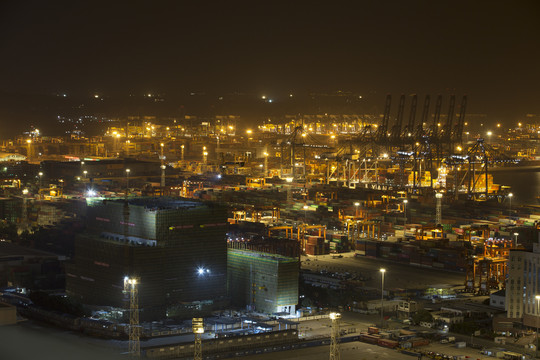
302, 253, 465, 289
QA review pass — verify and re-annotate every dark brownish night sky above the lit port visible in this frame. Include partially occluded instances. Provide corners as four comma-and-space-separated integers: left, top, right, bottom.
0, 0, 540, 132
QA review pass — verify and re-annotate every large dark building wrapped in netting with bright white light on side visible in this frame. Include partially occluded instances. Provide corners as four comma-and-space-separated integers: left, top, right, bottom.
66, 198, 227, 319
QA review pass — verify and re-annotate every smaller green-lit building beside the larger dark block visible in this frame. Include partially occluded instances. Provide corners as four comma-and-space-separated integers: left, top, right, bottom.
227, 248, 299, 315
